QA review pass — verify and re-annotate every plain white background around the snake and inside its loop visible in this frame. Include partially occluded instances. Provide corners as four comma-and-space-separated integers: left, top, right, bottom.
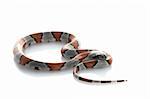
0, 0, 150, 99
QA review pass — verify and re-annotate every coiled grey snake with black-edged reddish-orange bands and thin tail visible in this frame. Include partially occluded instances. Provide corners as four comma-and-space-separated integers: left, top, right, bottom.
13, 31, 127, 83
